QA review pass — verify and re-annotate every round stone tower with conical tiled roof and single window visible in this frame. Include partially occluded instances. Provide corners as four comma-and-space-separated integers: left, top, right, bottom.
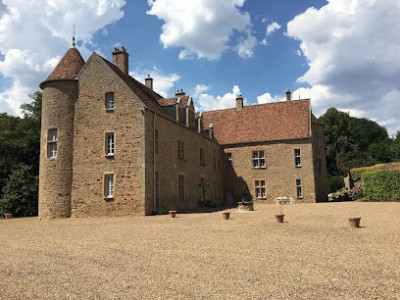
39, 47, 85, 219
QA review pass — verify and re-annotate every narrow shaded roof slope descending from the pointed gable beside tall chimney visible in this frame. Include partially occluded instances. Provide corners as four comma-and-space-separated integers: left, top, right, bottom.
102, 58, 169, 116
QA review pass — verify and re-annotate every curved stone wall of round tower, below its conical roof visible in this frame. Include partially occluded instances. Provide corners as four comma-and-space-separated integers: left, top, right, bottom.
39, 80, 78, 219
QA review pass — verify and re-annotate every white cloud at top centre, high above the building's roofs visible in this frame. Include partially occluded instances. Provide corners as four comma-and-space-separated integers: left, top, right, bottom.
147, 0, 257, 60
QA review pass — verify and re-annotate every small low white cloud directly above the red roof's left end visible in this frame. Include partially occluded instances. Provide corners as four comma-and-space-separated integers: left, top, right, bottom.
193, 84, 242, 111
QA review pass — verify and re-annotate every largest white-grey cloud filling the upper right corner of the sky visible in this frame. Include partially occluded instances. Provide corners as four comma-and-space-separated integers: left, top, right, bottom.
287, 0, 400, 132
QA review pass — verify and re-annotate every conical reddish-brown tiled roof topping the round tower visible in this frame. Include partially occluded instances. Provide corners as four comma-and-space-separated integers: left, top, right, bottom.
46, 47, 85, 81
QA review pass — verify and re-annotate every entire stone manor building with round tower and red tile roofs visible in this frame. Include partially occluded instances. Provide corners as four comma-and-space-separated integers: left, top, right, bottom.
39, 47, 326, 218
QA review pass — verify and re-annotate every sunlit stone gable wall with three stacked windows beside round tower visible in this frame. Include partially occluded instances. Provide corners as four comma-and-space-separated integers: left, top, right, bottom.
72, 57, 145, 217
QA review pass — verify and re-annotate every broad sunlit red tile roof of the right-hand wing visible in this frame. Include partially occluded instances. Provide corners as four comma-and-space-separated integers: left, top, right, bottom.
203, 99, 311, 144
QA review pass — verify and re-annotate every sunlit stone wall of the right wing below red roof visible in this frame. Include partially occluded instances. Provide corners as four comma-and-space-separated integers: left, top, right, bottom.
223, 138, 316, 203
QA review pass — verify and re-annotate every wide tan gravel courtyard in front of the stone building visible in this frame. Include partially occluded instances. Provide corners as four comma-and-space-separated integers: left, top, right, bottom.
0, 202, 400, 299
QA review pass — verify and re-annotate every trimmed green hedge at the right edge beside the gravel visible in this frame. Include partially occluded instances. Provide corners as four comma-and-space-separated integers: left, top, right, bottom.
361, 170, 400, 201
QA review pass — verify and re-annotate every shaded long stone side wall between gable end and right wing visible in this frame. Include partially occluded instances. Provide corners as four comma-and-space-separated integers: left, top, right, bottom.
146, 111, 223, 214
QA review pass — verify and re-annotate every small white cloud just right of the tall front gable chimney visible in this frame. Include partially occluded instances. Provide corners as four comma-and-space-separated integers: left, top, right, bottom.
130, 66, 180, 98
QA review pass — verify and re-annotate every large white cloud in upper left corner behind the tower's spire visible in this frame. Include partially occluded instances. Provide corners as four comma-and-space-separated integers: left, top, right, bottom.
0, 0, 125, 114
